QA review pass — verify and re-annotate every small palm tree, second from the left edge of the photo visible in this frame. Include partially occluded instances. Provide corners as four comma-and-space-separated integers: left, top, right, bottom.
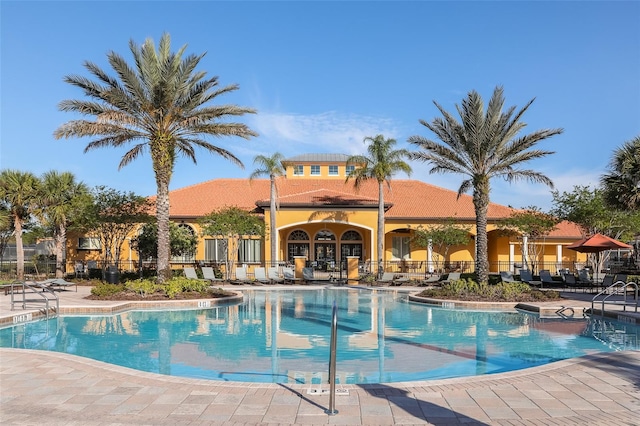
38, 170, 90, 278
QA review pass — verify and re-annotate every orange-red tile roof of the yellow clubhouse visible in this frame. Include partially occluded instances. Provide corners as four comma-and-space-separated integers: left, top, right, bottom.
170, 178, 580, 239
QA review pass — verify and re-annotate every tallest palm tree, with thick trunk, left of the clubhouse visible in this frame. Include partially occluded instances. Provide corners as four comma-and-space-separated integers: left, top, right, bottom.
54, 34, 257, 282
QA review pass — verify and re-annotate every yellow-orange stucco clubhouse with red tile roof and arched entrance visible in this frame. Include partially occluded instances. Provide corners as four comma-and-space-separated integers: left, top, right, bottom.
69, 154, 581, 272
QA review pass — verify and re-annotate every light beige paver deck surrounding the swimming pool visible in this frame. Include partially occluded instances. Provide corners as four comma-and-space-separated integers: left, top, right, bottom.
0, 286, 640, 426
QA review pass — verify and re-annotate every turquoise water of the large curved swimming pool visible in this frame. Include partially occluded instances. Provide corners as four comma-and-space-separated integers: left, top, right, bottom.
0, 288, 640, 384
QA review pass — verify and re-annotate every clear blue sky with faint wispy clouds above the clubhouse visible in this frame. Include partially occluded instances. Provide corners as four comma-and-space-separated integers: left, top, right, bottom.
0, 0, 640, 210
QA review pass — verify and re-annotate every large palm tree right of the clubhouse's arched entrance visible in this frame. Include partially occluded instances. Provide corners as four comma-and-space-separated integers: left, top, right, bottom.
409, 87, 563, 283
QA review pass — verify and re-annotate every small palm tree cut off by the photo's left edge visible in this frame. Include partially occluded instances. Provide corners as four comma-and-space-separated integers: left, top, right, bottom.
0, 169, 40, 280
